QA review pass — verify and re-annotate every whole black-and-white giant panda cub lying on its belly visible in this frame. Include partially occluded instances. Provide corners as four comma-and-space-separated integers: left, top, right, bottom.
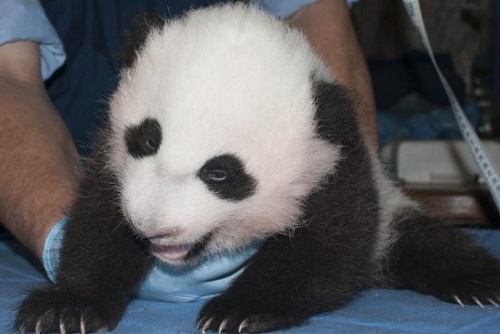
16, 4, 500, 332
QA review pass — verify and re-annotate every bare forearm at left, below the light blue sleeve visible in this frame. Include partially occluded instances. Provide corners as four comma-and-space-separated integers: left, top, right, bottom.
0, 42, 81, 258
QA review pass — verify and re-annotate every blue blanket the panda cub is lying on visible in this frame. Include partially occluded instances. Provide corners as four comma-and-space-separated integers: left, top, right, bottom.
0, 230, 500, 334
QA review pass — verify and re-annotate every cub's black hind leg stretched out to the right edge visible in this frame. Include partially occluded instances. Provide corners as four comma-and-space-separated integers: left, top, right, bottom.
386, 213, 500, 305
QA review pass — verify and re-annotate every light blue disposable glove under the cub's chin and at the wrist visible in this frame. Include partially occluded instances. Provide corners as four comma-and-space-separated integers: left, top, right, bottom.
42, 216, 257, 302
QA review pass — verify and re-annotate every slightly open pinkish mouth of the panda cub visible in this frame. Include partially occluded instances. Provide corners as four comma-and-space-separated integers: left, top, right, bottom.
151, 234, 211, 264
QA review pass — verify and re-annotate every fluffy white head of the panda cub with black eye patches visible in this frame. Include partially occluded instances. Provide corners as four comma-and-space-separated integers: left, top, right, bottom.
107, 4, 339, 265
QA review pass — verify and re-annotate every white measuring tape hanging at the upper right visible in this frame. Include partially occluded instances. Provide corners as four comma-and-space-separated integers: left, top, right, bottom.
402, 0, 500, 212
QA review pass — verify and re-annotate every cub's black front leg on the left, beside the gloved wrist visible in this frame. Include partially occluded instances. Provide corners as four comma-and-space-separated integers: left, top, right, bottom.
15, 145, 152, 333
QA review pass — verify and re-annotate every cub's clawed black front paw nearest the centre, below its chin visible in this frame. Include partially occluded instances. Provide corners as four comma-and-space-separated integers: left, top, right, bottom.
196, 294, 302, 333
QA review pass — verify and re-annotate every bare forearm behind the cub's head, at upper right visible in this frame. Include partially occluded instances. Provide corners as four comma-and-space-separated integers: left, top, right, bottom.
287, 0, 378, 146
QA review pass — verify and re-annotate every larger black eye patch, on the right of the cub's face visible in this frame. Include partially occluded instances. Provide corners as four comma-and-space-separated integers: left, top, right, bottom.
198, 154, 257, 201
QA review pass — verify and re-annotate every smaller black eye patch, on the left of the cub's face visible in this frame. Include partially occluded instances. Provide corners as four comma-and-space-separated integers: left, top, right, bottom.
125, 118, 162, 159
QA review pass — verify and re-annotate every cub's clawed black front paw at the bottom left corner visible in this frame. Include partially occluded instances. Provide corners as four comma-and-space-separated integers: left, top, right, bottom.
15, 288, 117, 334
